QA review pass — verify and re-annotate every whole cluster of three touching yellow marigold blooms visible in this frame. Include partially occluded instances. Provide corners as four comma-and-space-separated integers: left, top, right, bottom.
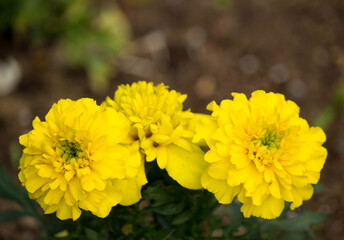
19, 81, 327, 220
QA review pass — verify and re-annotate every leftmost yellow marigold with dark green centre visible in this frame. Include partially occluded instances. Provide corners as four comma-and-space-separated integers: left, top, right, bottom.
19, 98, 146, 220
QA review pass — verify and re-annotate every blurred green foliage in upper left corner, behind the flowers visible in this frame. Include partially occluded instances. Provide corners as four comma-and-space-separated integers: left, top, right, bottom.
0, 0, 130, 91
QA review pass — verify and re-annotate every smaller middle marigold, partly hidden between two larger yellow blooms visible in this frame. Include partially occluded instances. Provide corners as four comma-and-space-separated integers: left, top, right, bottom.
103, 81, 207, 189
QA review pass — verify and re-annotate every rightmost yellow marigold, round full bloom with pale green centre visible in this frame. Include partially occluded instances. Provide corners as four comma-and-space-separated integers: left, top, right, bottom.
194, 90, 327, 219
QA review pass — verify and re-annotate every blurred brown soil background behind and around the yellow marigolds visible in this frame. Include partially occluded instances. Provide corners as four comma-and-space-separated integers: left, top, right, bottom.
0, 0, 344, 240
